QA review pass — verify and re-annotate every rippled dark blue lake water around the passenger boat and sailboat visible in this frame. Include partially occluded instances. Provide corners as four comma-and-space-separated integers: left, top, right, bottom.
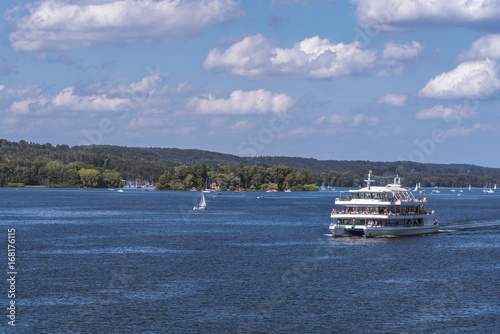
0, 189, 500, 333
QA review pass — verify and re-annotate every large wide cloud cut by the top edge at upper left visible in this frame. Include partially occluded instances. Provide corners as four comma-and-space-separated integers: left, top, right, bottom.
8, 0, 243, 51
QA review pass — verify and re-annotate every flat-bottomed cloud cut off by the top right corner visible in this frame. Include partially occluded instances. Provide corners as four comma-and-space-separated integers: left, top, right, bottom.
351, 0, 500, 31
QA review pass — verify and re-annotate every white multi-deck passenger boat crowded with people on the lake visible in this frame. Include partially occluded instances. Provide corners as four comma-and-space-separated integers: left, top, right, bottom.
330, 171, 439, 237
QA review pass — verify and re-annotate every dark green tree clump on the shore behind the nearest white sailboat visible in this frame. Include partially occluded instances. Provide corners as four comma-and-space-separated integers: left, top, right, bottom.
156, 163, 318, 191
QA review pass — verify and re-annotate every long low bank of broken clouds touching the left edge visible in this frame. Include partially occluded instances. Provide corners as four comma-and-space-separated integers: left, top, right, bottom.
0, 74, 184, 115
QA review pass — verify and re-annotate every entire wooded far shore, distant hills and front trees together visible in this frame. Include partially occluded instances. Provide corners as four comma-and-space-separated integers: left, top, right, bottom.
0, 139, 500, 190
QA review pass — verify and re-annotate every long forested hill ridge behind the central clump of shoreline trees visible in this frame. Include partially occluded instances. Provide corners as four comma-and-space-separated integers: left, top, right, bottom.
0, 139, 500, 189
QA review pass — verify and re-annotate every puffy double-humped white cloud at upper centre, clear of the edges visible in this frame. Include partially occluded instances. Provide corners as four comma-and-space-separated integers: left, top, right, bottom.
203, 34, 376, 78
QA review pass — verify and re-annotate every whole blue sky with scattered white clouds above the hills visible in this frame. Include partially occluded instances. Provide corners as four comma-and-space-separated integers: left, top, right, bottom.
0, 0, 500, 168
